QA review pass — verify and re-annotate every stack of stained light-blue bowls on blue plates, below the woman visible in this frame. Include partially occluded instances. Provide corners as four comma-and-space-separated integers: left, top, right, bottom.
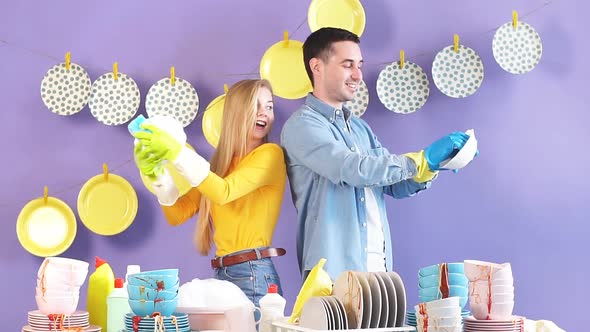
127, 269, 180, 317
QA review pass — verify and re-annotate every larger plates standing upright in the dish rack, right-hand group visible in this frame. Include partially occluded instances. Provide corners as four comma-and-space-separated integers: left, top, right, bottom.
332, 271, 406, 329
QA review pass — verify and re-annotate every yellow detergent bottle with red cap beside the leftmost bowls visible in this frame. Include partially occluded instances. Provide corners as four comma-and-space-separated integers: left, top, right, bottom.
86, 256, 115, 331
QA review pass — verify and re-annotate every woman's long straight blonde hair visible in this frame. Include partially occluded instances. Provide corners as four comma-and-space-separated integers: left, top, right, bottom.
194, 80, 272, 255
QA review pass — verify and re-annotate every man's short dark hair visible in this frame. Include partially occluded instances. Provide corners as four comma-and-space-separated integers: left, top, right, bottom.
303, 28, 361, 85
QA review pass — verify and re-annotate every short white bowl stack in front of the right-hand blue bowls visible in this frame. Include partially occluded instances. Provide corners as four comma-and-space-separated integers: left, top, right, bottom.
414, 296, 463, 332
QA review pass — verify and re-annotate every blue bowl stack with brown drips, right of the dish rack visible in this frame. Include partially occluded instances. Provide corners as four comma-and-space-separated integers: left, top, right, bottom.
418, 263, 469, 308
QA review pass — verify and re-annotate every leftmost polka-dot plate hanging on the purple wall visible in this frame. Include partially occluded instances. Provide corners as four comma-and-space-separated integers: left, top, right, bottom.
41, 63, 91, 115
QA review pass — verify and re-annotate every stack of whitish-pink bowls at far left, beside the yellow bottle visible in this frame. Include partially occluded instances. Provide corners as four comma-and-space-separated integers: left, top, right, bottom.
35, 257, 88, 315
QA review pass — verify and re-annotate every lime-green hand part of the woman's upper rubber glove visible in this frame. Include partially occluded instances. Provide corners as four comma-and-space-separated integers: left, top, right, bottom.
133, 124, 182, 161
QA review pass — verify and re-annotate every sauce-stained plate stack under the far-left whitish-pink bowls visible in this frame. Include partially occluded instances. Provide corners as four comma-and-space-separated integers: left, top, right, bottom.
22, 310, 101, 332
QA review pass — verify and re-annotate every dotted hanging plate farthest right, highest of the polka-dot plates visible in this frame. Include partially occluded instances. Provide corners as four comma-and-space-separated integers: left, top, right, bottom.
492, 22, 543, 74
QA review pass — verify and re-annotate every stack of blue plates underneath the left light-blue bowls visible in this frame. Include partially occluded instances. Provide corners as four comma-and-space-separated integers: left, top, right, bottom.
125, 313, 191, 332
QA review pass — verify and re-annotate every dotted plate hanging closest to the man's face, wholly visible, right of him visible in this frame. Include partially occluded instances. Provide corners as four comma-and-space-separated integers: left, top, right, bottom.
377, 61, 430, 114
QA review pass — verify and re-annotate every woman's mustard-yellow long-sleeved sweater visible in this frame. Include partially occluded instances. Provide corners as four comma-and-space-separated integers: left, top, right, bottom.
162, 143, 287, 256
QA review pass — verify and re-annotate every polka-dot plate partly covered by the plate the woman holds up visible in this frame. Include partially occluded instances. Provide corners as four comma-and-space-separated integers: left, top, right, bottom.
145, 77, 199, 127
